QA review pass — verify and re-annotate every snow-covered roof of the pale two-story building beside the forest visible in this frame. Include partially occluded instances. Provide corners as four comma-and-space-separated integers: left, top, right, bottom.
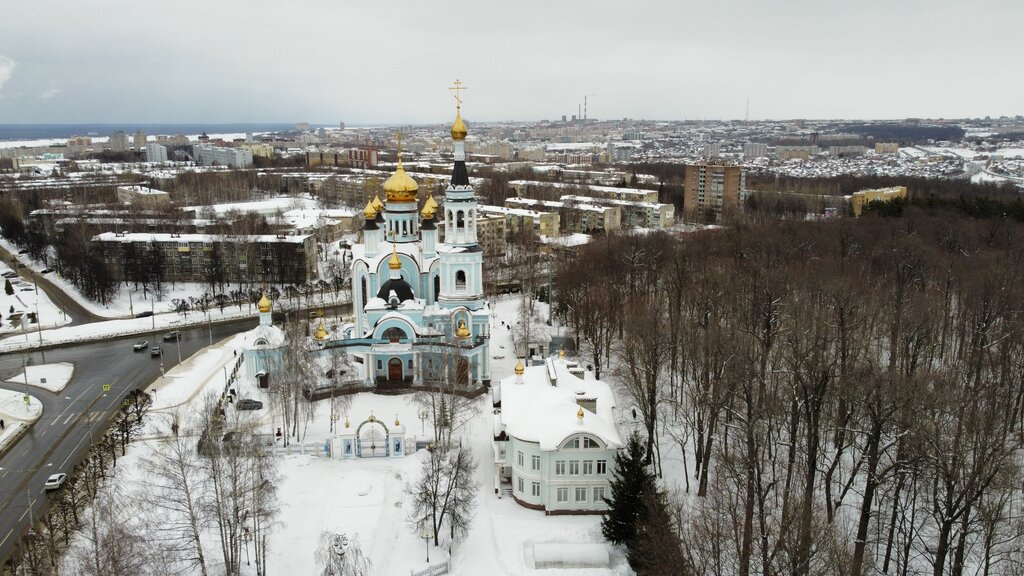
496, 358, 622, 450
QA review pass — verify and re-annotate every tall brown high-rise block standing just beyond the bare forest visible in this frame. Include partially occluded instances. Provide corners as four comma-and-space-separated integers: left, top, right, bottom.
683, 162, 746, 221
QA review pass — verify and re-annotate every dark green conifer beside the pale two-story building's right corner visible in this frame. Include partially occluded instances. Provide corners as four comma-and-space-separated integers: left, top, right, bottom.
601, 433, 654, 544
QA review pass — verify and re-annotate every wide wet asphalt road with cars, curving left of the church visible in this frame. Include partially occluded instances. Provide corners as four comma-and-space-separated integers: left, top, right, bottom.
0, 319, 257, 561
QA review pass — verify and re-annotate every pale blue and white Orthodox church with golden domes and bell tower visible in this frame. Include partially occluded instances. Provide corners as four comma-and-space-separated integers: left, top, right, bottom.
323, 90, 490, 388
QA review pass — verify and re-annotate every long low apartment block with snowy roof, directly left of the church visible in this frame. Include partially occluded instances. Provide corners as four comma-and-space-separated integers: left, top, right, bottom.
90, 232, 316, 284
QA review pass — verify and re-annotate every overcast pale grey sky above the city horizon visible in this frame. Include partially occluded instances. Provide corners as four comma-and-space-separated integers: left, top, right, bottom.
0, 0, 1024, 124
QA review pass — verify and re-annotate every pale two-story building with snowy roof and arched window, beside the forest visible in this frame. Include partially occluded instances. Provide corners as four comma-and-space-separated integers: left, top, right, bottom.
492, 358, 622, 513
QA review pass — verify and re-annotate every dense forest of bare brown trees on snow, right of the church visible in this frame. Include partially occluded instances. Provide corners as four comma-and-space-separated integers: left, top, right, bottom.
556, 210, 1024, 576
